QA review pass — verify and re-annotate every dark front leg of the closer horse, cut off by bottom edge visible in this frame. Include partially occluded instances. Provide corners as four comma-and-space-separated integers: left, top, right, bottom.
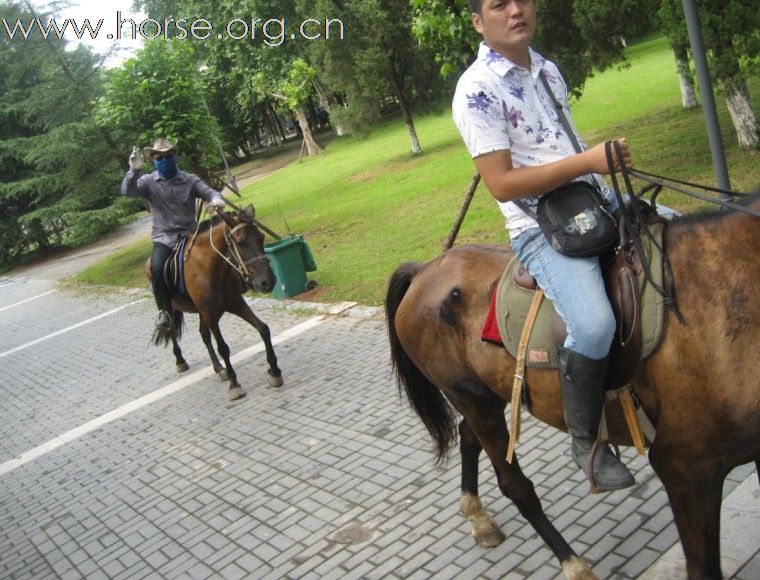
649, 446, 726, 580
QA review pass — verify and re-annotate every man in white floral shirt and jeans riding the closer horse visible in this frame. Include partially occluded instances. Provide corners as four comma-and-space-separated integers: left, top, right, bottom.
453, 0, 634, 491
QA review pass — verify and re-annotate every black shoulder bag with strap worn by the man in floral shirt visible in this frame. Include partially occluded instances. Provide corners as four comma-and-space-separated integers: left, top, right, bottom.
515, 71, 619, 258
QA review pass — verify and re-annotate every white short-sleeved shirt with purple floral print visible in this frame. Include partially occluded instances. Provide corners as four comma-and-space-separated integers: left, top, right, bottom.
452, 43, 608, 238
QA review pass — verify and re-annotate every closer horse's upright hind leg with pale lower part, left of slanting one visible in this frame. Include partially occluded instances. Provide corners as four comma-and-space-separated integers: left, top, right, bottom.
459, 419, 505, 548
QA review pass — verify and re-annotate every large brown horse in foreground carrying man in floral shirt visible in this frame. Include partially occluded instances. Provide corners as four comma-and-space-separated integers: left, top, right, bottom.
386, 196, 760, 578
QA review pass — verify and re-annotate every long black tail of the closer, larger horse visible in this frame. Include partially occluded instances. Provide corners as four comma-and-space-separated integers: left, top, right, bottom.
385, 263, 457, 463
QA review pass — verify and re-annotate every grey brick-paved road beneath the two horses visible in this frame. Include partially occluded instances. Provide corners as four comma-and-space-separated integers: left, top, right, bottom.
0, 278, 760, 580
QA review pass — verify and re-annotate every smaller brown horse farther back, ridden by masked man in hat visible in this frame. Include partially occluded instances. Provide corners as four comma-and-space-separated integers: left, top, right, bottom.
146, 206, 282, 401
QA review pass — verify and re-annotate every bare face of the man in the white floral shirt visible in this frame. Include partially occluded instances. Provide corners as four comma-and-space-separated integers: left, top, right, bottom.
472, 0, 536, 53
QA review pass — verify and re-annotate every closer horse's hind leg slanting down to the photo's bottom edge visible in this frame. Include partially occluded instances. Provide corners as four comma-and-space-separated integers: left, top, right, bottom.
447, 380, 596, 580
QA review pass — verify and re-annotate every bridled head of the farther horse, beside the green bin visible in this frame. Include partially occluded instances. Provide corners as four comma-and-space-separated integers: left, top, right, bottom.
219, 205, 276, 293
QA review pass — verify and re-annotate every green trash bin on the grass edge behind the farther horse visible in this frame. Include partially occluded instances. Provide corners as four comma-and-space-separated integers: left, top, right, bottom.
264, 235, 317, 298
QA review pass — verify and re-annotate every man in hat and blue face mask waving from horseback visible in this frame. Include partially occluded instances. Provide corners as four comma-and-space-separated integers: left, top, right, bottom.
121, 138, 225, 331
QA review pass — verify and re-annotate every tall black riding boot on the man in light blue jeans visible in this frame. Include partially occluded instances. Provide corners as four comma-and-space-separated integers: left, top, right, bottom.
559, 348, 635, 492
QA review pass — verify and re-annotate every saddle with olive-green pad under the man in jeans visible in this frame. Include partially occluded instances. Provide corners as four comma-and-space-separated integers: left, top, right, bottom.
490, 204, 666, 390
